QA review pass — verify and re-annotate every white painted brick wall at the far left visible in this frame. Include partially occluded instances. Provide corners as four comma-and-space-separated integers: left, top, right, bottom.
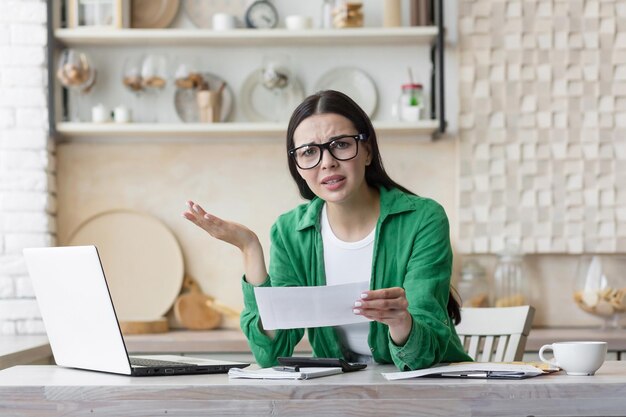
0, 0, 56, 334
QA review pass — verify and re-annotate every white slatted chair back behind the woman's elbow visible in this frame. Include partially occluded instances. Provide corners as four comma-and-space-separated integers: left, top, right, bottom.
456, 306, 535, 362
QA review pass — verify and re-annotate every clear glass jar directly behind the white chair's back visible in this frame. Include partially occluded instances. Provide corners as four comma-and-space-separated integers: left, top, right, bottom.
494, 247, 529, 307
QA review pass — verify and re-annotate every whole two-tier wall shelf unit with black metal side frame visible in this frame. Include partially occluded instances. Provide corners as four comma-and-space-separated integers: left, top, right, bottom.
48, 0, 446, 141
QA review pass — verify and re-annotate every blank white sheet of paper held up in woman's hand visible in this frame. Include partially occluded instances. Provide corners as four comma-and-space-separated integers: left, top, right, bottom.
254, 281, 369, 330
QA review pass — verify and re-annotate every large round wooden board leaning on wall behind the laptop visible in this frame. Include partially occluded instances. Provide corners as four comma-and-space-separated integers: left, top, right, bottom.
69, 210, 184, 321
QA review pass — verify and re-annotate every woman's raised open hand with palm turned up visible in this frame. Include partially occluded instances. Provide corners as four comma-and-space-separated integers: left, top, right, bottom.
183, 201, 258, 251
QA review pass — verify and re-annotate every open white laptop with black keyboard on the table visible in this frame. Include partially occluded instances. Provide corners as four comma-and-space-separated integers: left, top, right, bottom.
24, 246, 249, 376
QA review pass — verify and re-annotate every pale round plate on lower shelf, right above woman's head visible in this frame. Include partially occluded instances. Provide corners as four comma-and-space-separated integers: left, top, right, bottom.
315, 67, 378, 117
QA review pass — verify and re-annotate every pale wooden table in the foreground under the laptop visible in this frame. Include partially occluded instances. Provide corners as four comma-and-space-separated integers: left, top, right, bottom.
0, 361, 626, 417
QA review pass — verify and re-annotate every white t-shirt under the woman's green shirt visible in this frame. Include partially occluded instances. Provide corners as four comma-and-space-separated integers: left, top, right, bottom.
321, 204, 376, 355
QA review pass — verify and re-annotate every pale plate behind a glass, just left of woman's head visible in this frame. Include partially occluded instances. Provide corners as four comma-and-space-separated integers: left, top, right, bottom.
239, 68, 304, 122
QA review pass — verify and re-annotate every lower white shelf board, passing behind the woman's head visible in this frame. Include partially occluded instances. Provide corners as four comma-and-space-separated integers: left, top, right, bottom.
56, 120, 439, 140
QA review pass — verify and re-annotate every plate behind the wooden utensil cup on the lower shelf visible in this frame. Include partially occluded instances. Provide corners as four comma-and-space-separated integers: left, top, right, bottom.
174, 72, 233, 123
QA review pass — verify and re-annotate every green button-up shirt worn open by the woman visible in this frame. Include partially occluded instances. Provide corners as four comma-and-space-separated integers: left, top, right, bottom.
241, 188, 471, 370
